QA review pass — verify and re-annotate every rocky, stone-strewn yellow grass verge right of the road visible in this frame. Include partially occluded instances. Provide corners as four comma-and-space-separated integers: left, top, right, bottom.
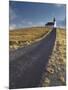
41, 29, 66, 87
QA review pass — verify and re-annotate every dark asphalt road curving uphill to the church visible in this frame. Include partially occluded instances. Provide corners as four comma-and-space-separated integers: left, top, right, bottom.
9, 29, 56, 89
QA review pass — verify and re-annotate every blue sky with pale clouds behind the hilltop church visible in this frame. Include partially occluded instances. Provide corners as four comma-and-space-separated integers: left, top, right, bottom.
9, 1, 66, 30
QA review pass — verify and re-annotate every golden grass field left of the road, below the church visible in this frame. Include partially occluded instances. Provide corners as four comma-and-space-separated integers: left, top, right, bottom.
9, 27, 50, 49
